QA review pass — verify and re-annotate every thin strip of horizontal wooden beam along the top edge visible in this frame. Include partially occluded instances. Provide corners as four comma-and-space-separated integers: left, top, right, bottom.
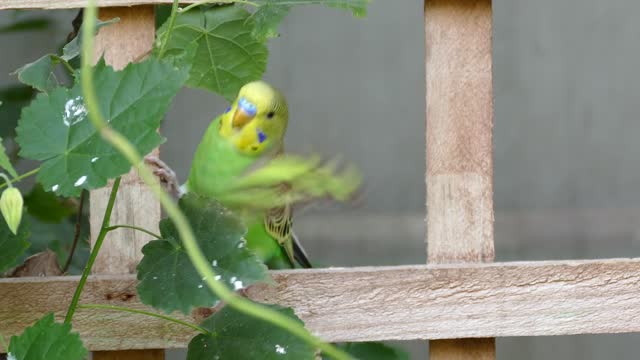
0, 0, 192, 10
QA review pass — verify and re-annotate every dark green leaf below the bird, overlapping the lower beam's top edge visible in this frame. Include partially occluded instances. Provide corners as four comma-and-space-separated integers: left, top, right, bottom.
138, 194, 269, 314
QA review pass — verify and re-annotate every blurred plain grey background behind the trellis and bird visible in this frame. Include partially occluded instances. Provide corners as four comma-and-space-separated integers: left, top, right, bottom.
0, 0, 640, 360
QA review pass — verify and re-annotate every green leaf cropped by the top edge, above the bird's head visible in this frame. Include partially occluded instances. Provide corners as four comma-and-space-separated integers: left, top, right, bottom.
251, 0, 370, 40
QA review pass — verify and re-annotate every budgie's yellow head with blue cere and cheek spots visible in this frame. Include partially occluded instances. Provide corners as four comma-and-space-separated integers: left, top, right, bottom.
219, 81, 289, 156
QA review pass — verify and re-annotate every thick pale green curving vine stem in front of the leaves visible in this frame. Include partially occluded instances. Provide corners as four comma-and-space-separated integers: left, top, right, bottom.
80, 0, 351, 360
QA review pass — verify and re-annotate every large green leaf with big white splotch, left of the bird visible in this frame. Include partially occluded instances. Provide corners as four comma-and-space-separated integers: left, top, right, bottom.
16, 58, 188, 196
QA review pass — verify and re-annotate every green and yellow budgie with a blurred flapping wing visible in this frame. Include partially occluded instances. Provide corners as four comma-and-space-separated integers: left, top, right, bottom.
146, 81, 361, 269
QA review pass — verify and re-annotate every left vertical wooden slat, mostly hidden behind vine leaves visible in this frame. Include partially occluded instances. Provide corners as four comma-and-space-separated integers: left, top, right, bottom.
90, 6, 164, 360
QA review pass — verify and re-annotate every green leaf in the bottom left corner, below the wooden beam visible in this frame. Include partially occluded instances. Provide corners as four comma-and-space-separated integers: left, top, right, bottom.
9, 313, 88, 360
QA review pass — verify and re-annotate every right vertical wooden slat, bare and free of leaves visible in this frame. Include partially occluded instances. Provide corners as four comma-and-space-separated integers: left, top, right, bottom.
424, 0, 495, 360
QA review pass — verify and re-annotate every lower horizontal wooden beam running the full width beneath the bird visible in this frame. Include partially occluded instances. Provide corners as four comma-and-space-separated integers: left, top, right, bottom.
0, 259, 640, 352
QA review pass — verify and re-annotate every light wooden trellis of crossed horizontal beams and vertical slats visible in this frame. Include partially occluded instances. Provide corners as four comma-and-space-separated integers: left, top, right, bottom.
0, 0, 640, 360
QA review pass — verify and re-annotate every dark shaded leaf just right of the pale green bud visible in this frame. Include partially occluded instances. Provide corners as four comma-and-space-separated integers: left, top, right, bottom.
24, 183, 77, 223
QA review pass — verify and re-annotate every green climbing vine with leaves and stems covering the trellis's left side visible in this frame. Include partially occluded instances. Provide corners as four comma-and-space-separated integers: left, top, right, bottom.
0, 0, 407, 360
